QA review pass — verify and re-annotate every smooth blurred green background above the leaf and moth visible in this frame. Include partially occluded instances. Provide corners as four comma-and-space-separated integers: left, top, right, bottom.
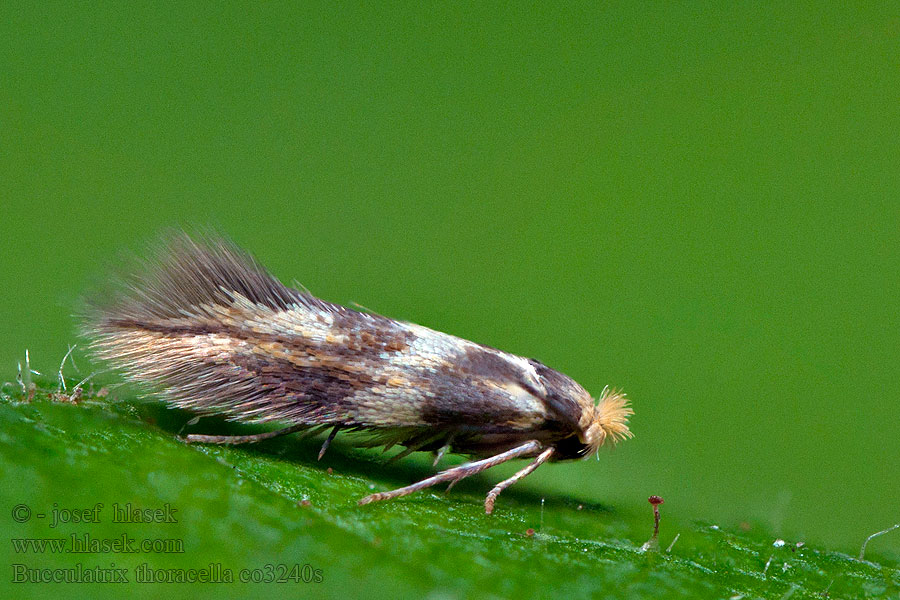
0, 3, 900, 552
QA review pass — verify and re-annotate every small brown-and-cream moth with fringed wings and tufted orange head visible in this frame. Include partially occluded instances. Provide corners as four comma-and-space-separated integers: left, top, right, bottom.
83, 233, 633, 513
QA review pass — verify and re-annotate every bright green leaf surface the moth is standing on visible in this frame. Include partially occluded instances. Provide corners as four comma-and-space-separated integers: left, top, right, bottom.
0, 383, 900, 599
